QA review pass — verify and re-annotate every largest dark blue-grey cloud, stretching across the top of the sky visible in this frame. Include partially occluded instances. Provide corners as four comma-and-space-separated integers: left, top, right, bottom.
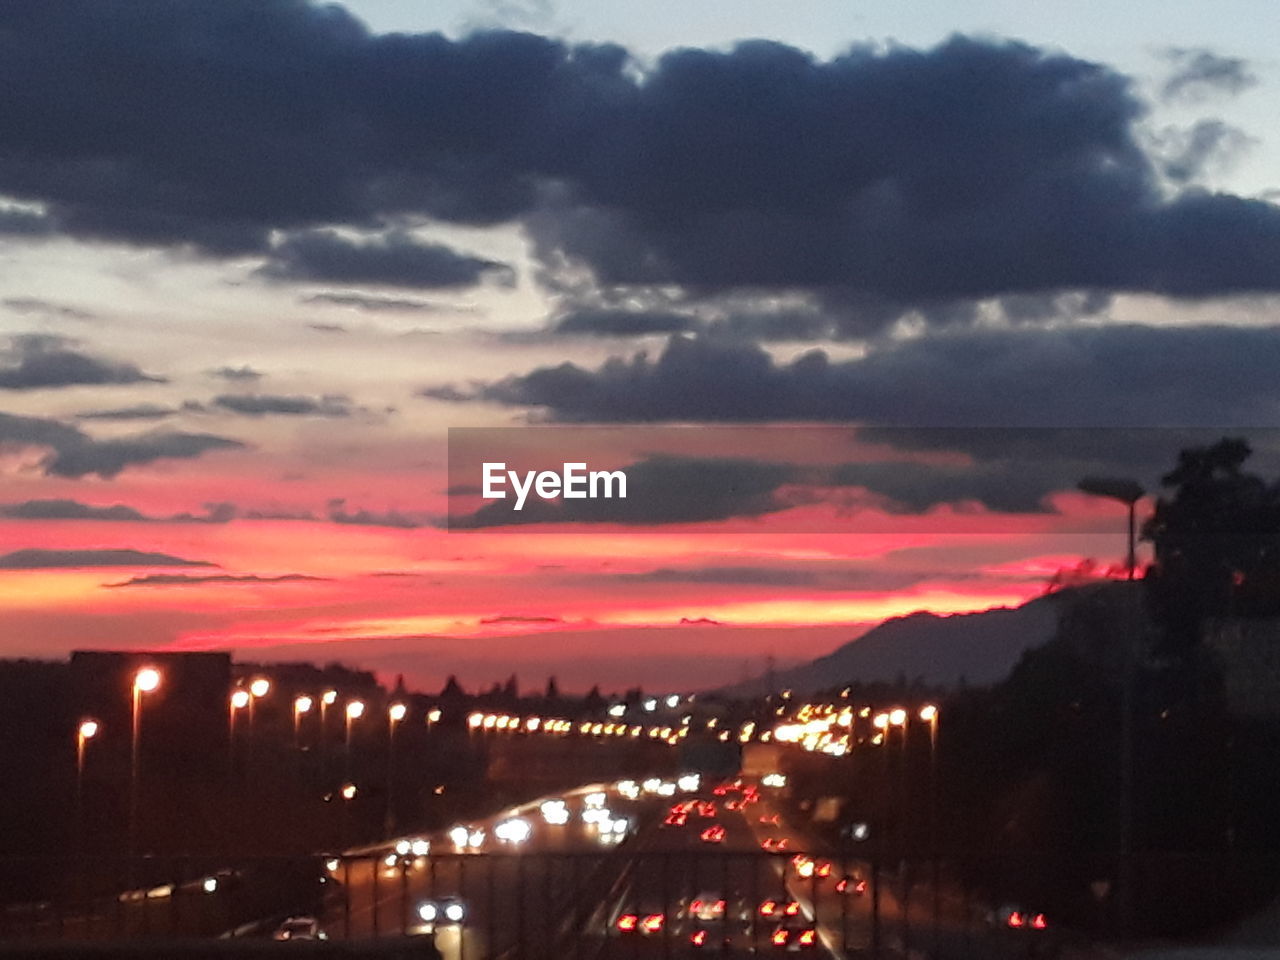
0, 0, 1280, 305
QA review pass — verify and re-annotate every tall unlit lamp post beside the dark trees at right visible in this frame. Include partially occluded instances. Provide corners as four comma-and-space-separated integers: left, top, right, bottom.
1076, 476, 1147, 933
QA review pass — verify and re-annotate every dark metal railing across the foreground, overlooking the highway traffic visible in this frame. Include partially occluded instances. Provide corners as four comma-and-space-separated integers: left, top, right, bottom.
0, 855, 1095, 960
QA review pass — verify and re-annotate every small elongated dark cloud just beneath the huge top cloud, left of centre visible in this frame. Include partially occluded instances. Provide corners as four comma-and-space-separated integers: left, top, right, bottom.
259, 230, 515, 288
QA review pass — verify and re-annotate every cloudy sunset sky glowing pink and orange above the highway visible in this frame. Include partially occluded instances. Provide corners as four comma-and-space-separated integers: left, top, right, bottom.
0, 0, 1280, 690
